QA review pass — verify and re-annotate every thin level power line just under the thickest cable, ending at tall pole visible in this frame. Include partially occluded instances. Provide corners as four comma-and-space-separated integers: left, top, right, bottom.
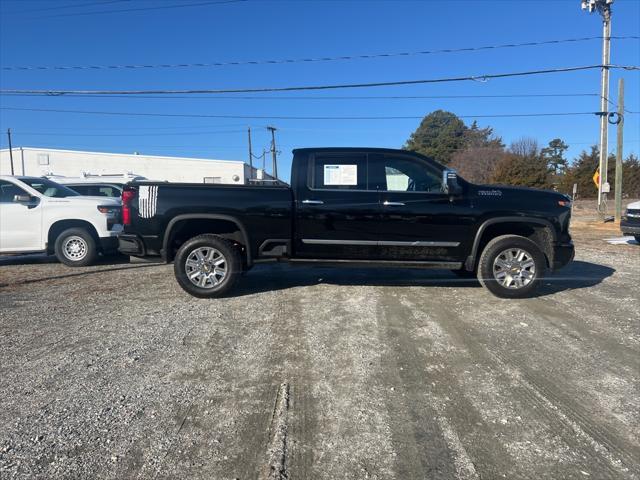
0, 91, 613, 103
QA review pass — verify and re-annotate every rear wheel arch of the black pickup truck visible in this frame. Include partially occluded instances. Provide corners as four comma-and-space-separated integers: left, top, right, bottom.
160, 213, 253, 266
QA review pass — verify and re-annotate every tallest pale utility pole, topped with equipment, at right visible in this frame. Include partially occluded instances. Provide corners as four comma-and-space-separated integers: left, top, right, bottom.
582, 0, 613, 218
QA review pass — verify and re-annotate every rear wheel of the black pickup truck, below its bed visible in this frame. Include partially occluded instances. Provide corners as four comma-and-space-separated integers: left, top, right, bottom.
173, 234, 242, 298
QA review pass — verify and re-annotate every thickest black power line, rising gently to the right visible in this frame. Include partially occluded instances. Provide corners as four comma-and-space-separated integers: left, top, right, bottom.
0, 65, 640, 96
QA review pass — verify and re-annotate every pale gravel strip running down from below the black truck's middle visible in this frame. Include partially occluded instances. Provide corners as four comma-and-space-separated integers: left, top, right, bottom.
294, 280, 398, 480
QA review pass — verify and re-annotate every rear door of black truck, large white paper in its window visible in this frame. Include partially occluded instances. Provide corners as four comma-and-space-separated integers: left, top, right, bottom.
295, 152, 380, 259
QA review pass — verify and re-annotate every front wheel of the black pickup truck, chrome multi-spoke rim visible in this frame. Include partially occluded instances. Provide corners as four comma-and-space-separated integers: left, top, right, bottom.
478, 235, 546, 298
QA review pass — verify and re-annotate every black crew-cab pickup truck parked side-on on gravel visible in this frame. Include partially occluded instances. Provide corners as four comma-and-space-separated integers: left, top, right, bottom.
119, 148, 574, 298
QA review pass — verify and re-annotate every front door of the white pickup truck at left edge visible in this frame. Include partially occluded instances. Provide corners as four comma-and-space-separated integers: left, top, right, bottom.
0, 180, 44, 253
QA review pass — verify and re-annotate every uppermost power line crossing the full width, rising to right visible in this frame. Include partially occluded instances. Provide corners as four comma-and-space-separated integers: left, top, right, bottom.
2, 35, 640, 70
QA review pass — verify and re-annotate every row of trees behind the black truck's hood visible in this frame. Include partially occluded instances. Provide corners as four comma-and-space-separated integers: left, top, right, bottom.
403, 110, 640, 198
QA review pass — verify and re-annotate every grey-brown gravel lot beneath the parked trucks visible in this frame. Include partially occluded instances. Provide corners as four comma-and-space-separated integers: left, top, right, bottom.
0, 218, 640, 479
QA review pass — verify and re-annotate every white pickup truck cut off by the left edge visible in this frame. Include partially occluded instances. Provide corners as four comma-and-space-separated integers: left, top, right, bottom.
0, 176, 122, 267
